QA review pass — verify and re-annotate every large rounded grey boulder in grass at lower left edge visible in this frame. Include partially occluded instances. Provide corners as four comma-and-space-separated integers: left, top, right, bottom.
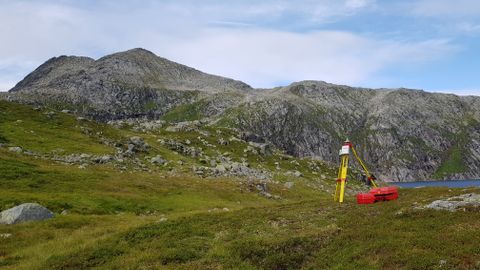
0, 203, 53, 224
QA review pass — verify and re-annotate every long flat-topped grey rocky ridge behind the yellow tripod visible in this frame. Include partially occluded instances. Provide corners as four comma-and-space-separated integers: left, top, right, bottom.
220, 81, 480, 181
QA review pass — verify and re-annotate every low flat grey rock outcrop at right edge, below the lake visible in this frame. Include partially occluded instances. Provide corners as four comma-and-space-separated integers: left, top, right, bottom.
425, 193, 480, 212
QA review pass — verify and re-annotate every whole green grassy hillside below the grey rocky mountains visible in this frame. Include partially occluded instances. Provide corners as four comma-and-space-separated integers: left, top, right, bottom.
0, 101, 480, 269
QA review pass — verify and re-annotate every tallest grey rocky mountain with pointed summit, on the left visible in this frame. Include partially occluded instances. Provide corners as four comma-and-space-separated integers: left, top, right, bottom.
9, 49, 251, 120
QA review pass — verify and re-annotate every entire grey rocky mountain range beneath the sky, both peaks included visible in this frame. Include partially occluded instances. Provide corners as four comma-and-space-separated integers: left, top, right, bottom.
8, 49, 480, 181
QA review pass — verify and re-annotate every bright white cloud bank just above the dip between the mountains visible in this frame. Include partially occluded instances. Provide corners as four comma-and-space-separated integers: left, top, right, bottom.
154, 29, 456, 87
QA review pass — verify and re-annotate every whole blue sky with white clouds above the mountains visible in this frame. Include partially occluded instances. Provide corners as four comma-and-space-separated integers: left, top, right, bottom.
0, 0, 480, 95
